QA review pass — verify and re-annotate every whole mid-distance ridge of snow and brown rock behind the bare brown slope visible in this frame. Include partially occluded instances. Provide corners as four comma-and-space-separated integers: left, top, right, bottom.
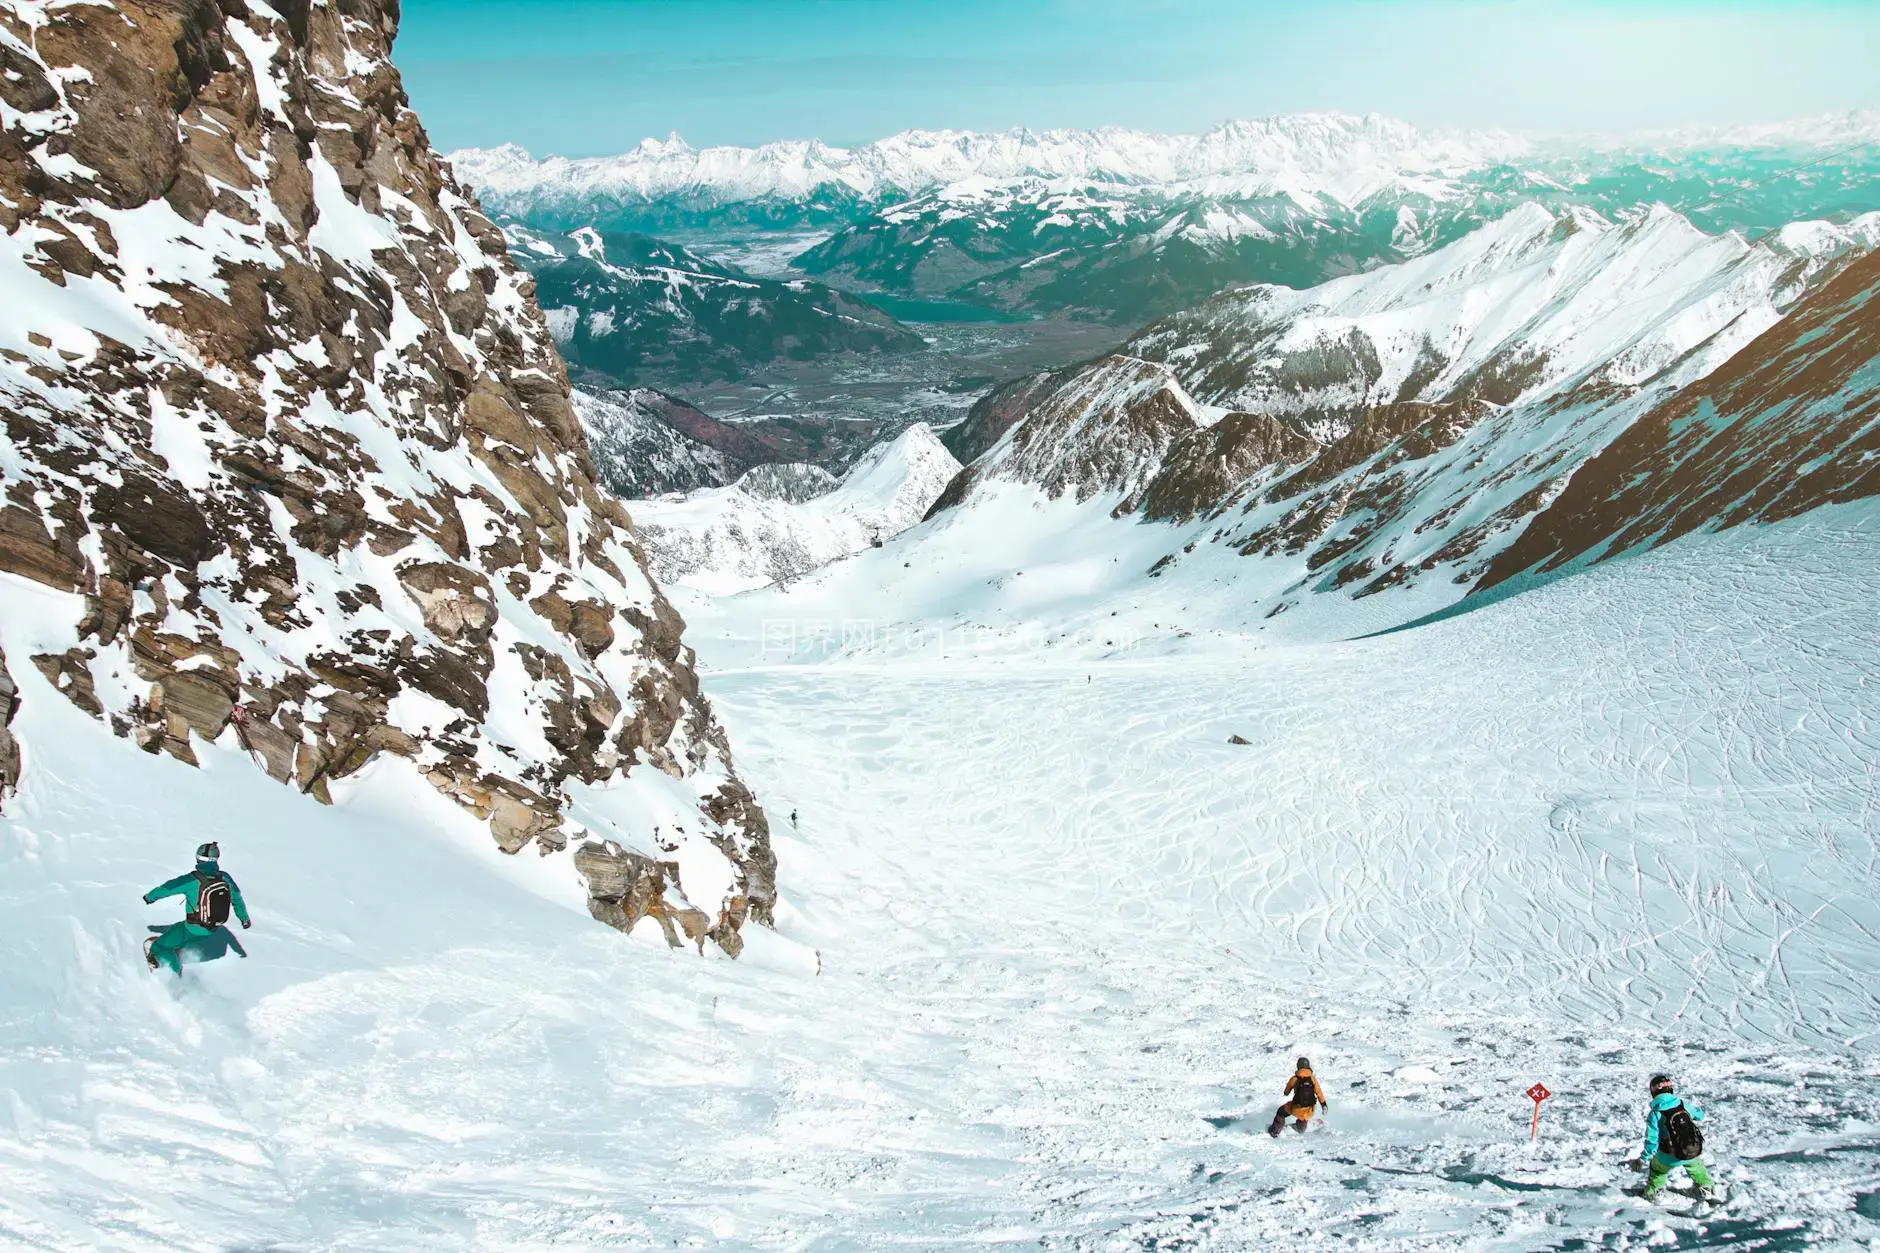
940, 207, 1880, 625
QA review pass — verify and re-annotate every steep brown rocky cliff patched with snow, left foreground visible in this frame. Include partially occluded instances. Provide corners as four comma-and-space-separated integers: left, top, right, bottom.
0, 0, 775, 952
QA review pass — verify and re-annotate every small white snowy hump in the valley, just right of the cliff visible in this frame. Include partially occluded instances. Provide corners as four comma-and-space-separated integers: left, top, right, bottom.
634, 423, 959, 593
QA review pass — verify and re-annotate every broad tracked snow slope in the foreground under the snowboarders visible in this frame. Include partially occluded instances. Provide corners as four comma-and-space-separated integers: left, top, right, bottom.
0, 506, 1880, 1251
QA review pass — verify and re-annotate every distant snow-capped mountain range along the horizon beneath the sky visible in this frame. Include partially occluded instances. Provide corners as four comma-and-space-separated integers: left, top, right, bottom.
455, 113, 1880, 325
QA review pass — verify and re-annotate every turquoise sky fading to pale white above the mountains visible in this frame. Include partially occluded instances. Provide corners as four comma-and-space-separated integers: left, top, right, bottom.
397, 0, 1880, 156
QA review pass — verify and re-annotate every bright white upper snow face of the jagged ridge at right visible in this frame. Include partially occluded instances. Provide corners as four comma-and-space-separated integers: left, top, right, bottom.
1130, 205, 1880, 419
